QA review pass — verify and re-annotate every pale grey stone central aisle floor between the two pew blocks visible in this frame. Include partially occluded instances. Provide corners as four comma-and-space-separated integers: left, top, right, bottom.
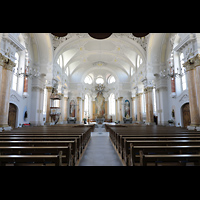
79, 128, 123, 166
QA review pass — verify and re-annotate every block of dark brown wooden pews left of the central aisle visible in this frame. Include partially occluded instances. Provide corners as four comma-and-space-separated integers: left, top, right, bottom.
0, 124, 94, 166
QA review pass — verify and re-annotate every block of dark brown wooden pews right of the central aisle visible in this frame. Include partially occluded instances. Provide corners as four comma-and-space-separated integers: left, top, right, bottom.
105, 124, 200, 166
